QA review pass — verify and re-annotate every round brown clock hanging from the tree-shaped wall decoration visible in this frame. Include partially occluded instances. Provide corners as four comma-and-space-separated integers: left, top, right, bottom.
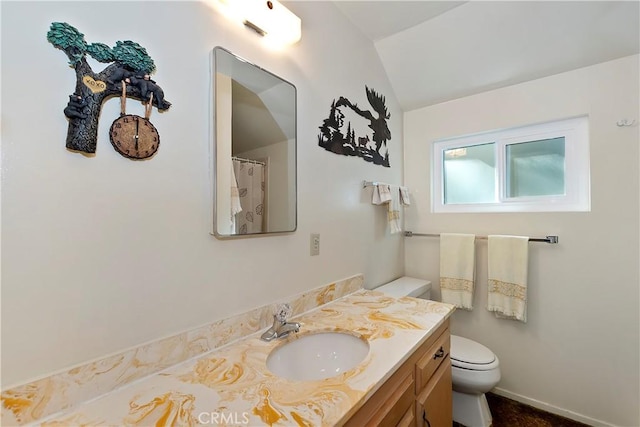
109, 114, 160, 159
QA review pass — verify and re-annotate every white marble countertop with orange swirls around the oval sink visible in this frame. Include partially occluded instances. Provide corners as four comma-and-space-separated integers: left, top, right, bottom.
39, 290, 453, 426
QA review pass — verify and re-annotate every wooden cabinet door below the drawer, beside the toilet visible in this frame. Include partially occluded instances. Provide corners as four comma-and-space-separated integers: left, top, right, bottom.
416, 357, 453, 427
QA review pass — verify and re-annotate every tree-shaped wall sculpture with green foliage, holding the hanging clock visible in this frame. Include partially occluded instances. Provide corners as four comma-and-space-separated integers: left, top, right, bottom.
47, 22, 171, 153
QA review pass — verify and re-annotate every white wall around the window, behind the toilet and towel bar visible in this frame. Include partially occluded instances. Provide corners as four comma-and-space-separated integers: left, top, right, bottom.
404, 56, 640, 426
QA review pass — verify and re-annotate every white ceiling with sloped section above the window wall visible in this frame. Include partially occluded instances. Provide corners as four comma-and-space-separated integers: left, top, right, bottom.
334, 0, 640, 111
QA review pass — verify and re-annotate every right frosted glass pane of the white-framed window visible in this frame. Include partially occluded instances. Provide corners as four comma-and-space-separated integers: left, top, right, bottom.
506, 137, 565, 197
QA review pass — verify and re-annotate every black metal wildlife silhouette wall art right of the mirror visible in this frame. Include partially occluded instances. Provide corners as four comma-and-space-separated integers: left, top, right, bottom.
318, 86, 391, 167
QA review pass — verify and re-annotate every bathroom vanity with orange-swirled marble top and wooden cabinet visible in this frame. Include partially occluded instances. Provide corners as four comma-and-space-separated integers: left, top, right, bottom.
22, 289, 454, 427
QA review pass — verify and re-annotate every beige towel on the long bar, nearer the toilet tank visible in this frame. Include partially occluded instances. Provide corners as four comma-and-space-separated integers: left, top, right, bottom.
440, 233, 476, 310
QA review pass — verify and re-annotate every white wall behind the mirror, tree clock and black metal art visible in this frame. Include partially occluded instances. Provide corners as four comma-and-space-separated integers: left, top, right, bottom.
1, 1, 403, 389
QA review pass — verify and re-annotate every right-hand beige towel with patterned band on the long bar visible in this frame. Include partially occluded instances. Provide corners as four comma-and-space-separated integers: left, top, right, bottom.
487, 236, 529, 323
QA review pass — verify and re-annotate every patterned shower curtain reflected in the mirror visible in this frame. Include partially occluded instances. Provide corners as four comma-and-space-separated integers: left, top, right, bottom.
231, 157, 267, 234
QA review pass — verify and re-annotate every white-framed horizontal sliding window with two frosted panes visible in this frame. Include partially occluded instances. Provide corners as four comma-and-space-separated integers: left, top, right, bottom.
432, 117, 590, 212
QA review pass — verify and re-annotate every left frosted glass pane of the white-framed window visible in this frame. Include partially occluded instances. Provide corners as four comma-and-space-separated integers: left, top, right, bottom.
443, 143, 496, 204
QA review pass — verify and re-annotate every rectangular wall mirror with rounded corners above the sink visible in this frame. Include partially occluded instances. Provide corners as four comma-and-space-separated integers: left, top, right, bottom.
211, 47, 297, 238
